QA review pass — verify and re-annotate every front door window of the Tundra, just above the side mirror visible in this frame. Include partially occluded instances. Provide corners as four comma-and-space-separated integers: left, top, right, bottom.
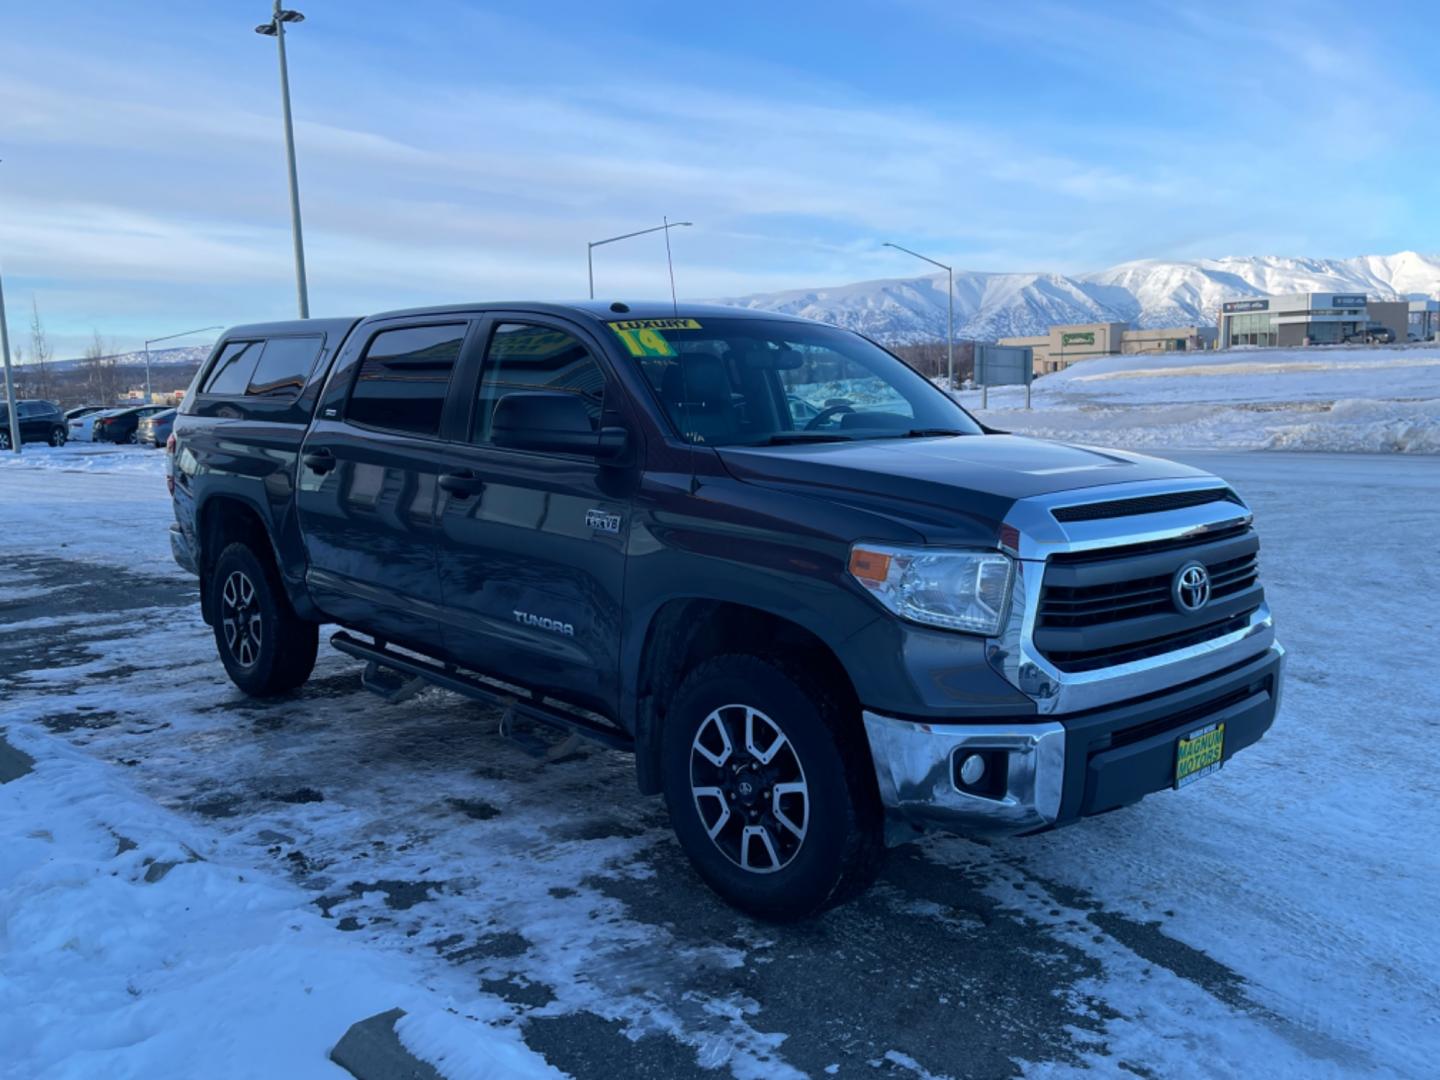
474, 323, 605, 442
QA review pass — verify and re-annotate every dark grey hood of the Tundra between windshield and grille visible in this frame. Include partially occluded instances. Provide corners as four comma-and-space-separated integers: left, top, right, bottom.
717, 435, 1208, 536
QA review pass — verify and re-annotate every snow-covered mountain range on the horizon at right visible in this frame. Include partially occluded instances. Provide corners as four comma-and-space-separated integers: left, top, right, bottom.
723, 251, 1440, 344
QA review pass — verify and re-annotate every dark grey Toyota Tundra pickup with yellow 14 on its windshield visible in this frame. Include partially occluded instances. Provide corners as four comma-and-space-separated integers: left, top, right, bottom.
167, 302, 1284, 919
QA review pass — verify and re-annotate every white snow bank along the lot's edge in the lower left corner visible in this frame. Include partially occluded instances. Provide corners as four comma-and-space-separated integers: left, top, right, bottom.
0, 727, 559, 1079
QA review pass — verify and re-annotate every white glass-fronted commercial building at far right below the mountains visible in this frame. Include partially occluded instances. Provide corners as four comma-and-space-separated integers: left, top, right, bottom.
1220, 292, 1410, 348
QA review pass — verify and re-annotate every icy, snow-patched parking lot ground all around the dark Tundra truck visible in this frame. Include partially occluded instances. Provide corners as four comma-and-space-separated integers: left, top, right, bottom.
0, 448, 1440, 1079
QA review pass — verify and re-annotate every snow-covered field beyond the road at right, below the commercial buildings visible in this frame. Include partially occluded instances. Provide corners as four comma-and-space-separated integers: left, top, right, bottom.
958, 346, 1440, 454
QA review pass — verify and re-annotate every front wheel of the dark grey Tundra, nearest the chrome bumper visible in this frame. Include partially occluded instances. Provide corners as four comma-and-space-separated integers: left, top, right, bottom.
662, 655, 884, 922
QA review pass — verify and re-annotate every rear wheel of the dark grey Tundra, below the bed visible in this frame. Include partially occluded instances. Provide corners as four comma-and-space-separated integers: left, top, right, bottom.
210, 543, 320, 697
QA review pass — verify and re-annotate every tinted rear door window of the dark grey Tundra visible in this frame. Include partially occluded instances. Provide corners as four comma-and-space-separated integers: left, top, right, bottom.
346, 323, 467, 435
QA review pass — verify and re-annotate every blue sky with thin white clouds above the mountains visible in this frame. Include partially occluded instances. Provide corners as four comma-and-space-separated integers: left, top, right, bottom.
0, 0, 1440, 356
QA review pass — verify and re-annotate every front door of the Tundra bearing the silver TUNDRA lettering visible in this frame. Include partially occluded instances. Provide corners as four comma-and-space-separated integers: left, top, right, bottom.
438, 315, 629, 711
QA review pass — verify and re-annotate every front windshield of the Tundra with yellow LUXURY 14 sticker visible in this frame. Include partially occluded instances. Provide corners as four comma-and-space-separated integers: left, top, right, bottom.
609, 317, 981, 446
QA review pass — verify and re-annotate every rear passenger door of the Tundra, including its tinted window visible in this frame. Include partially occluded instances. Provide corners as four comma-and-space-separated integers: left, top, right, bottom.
297, 317, 471, 652
